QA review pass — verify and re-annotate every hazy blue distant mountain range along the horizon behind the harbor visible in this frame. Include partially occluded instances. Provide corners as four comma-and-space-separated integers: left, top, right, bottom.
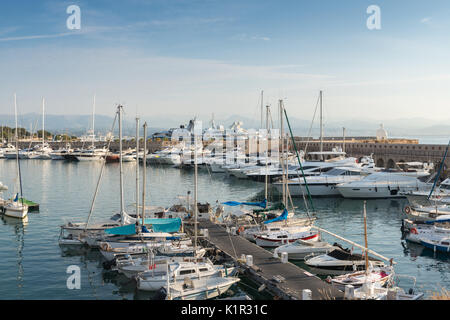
0, 113, 450, 137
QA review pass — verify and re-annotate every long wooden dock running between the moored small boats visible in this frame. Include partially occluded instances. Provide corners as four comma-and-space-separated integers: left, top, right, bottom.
191, 221, 344, 300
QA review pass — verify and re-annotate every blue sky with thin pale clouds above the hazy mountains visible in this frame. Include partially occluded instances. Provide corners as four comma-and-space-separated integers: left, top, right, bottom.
0, 0, 450, 124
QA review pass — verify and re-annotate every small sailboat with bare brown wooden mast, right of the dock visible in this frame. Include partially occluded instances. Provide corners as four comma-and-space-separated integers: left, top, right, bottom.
328, 201, 394, 291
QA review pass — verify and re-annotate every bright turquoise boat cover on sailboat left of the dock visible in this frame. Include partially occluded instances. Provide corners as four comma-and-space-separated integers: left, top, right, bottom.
105, 218, 181, 235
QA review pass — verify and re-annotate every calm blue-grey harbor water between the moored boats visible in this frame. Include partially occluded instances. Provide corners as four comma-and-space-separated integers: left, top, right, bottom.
0, 159, 450, 299
